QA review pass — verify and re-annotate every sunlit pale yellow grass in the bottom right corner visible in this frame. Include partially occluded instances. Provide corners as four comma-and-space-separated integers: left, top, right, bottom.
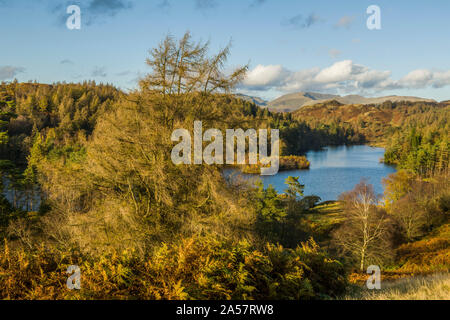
341, 273, 450, 300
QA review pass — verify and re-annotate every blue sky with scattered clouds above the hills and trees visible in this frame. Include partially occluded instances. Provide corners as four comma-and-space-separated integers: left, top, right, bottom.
0, 0, 450, 101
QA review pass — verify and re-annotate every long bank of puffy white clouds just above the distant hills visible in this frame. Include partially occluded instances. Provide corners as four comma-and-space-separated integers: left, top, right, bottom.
243, 60, 450, 93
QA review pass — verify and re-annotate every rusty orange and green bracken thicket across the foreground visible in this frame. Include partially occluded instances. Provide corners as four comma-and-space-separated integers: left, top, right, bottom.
0, 238, 346, 300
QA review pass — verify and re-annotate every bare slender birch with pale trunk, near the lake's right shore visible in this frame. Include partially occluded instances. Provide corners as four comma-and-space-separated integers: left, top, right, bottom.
332, 181, 392, 272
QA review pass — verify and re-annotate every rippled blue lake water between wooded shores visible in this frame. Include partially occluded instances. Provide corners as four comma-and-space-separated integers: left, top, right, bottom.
248, 145, 396, 201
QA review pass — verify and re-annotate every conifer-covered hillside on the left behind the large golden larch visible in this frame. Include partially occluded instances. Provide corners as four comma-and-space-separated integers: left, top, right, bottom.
0, 81, 122, 163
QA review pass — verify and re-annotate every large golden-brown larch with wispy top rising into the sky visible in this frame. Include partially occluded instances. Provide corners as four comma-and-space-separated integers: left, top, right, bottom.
38, 33, 254, 253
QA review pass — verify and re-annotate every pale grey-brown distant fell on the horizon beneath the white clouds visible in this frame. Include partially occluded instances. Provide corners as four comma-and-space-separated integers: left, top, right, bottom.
267, 92, 436, 112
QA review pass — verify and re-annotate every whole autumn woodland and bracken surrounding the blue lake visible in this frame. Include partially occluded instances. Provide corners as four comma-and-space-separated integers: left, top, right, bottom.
0, 33, 450, 300
